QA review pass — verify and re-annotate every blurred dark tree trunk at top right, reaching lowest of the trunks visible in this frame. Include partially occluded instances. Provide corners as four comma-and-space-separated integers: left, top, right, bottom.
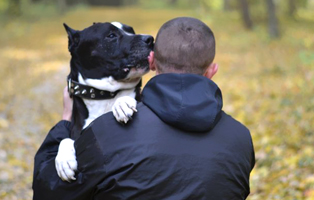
266, 0, 280, 38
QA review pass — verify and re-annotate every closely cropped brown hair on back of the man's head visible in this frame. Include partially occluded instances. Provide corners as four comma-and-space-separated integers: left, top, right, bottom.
154, 17, 215, 75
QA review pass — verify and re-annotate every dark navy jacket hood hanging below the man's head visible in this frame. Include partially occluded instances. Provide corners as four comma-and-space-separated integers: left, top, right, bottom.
142, 73, 222, 132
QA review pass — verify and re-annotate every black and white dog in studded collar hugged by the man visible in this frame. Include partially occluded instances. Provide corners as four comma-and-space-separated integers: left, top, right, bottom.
55, 22, 154, 181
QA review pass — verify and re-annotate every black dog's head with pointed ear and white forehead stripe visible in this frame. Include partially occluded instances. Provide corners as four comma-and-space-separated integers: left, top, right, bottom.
64, 22, 154, 81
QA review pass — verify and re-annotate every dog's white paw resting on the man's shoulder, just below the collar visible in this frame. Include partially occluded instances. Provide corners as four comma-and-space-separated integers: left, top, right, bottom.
112, 96, 137, 124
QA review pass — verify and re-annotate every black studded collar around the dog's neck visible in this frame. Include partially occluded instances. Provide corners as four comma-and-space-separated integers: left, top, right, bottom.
68, 79, 121, 100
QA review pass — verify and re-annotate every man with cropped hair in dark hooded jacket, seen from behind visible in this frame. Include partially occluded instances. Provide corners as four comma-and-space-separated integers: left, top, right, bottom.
33, 17, 255, 200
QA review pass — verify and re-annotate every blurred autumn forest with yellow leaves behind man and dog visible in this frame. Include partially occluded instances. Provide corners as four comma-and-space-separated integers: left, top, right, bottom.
0, 0, 314, 200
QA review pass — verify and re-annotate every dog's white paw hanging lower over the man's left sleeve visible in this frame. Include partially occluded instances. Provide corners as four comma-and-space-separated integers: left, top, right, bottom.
55, 138, 77, 182
